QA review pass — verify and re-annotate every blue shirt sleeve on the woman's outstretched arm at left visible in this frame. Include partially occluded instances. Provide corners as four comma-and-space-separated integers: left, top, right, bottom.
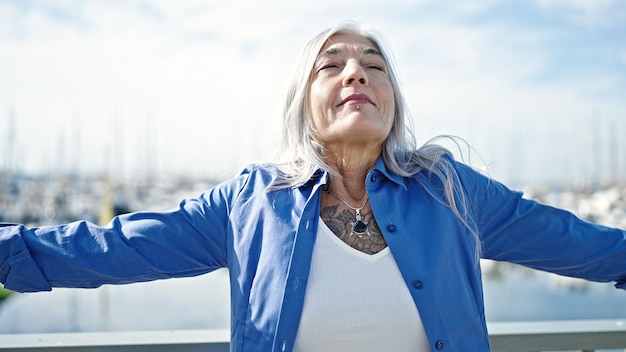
0, 175, 245, 292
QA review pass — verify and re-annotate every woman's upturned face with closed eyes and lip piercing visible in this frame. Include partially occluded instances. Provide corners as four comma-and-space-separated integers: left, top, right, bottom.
308, 34, 395, 148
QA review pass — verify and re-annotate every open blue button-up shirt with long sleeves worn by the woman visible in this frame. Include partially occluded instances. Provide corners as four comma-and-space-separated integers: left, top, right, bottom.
0, 160, 626, 352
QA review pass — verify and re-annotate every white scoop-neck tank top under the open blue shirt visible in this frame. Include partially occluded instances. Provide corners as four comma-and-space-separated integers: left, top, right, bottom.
294, 219, 431, 352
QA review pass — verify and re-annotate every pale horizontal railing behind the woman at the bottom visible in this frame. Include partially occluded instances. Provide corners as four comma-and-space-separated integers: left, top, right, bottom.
0, 319, 626, 352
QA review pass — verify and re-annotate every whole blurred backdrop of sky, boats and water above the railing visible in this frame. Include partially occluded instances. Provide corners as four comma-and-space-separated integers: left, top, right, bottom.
0, 0, 626, 333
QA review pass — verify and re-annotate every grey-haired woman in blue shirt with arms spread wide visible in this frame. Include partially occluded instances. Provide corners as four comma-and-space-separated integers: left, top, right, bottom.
0, 24, 626, 351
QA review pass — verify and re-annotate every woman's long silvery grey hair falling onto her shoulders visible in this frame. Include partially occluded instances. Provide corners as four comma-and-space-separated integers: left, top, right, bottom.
272, 22, 480, 253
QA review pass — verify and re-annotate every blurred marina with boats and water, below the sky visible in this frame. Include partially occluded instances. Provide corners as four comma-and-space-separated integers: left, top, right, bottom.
0, 174, 626, 334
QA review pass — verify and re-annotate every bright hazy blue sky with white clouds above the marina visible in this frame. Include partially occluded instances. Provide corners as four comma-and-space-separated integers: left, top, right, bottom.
0, 0, 626, 185
